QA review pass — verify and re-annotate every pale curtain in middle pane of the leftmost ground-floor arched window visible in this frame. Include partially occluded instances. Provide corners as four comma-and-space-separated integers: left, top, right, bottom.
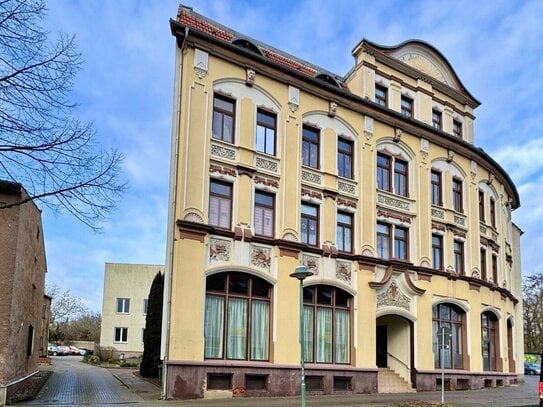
226, 297, 247, 359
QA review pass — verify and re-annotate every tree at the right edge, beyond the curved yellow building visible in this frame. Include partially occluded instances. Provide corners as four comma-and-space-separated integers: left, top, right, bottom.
522, 271, 543, 353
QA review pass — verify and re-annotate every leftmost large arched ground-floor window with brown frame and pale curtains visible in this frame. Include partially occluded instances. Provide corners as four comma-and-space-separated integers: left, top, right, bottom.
204, 273, 271, 360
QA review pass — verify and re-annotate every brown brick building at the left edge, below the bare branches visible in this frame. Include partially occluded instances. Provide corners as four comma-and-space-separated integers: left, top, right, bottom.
0, 181, 48, 405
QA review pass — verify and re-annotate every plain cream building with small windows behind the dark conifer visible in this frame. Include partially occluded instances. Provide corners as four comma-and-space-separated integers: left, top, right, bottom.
100, 263, 164, 357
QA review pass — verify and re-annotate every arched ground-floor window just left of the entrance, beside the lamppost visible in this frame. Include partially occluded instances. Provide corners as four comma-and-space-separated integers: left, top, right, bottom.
303, 285, 352, 364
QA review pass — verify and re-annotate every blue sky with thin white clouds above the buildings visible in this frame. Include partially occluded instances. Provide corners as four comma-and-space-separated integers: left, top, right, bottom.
43, 0, 543, 311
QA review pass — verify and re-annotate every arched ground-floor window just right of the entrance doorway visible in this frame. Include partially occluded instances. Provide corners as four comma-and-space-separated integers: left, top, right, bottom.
432, 304, 465, 369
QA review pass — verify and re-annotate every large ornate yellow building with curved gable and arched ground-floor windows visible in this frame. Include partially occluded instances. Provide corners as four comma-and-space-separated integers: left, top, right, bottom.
162, 6, 523, 398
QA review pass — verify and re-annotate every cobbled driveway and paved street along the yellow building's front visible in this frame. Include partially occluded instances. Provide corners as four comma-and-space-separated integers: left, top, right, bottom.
18, 356, 539, 407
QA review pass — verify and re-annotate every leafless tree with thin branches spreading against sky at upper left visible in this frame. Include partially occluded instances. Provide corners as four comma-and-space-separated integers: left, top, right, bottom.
0, 0, 126, 230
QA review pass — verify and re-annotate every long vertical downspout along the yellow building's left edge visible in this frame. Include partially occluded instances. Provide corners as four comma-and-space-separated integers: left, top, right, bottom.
160, 27, 189, 399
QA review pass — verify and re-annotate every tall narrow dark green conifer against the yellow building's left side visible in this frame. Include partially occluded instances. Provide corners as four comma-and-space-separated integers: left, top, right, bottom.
140, 272, 164, 377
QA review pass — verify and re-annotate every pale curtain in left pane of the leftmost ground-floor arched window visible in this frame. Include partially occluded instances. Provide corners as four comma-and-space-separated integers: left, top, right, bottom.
204, 295, 224, 359
